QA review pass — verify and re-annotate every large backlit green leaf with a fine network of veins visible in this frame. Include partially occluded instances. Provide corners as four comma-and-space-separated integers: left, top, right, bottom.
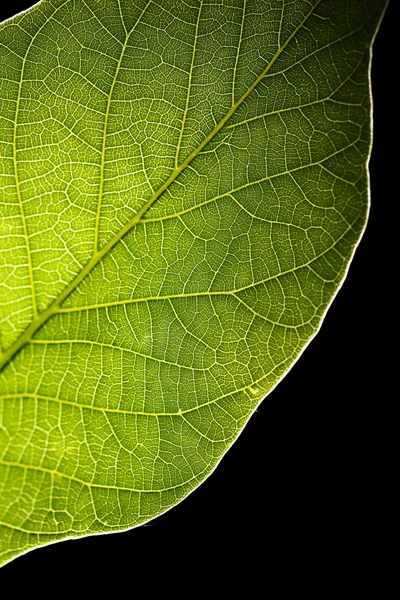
0, 0, 385, 564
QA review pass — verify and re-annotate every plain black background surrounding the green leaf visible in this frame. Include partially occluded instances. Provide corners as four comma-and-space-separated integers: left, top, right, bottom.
0, 1, 390, 589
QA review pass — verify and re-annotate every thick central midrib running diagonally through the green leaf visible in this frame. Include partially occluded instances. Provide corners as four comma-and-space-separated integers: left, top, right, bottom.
0, 0, 322, 371
